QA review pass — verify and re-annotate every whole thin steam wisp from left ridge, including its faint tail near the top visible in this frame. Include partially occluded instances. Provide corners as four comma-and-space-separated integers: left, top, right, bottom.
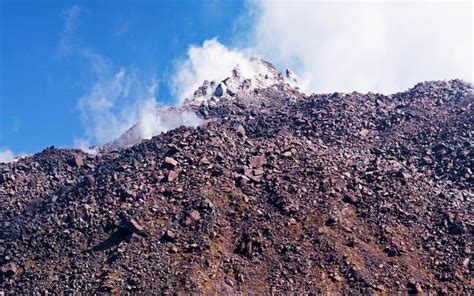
58, 5, 201, 149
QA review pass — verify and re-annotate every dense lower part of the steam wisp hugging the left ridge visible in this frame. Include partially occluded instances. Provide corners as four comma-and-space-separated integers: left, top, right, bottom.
75, 52, 203, 149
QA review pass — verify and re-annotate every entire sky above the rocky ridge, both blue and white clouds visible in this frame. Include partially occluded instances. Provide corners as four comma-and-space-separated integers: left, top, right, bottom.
0, 0, 473, 161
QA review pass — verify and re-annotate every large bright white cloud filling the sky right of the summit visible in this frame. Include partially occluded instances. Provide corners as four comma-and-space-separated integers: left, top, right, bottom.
246, 1, 473, 93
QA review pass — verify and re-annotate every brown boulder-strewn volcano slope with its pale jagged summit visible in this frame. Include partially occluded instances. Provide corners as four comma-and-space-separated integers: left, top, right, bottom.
0, 61, 474, 295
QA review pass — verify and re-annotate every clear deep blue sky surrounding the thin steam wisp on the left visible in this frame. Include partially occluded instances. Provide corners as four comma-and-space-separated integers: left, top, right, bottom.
0, 0, 250, 153
